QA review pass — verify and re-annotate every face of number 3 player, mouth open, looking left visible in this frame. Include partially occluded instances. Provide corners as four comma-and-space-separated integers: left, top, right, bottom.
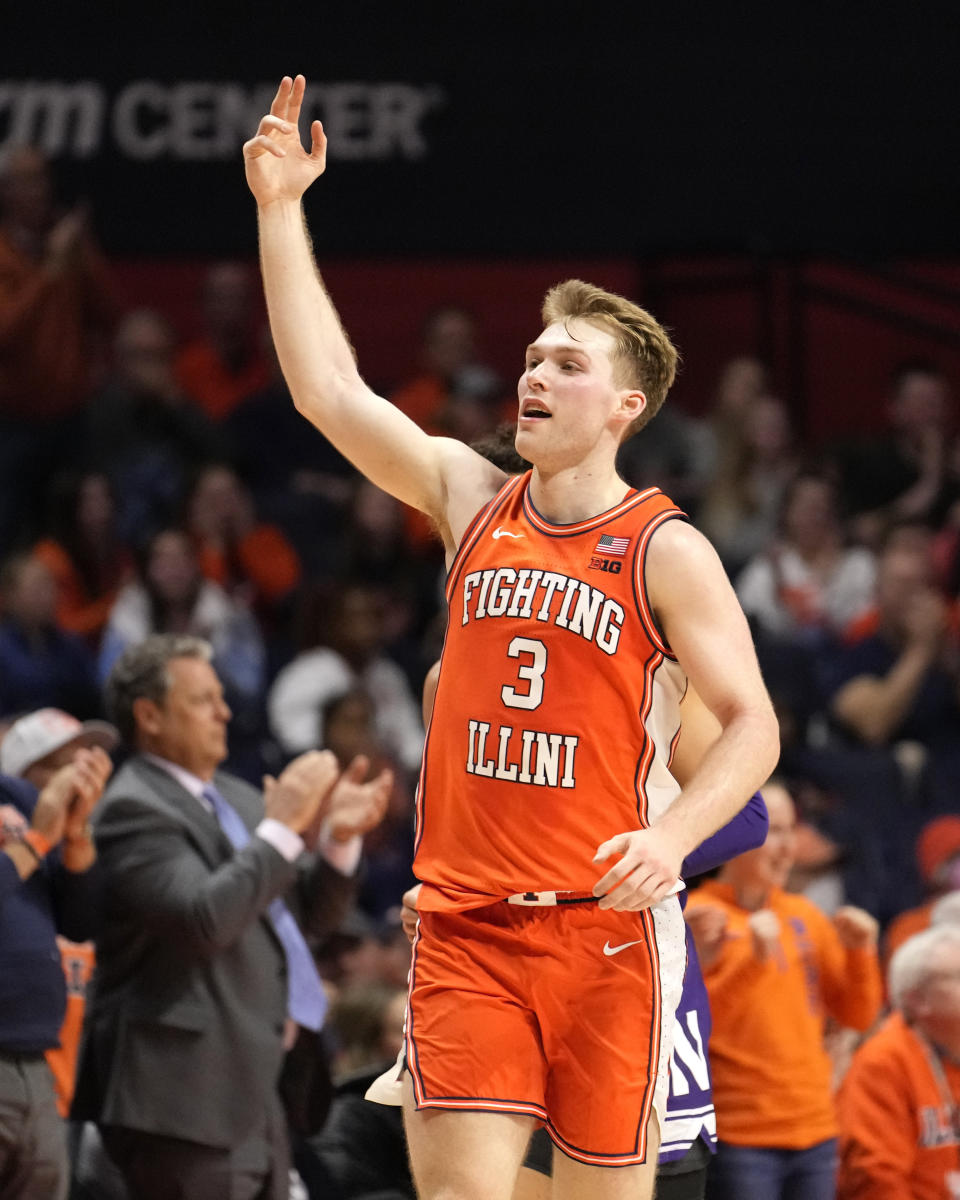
516, 320, 637, 466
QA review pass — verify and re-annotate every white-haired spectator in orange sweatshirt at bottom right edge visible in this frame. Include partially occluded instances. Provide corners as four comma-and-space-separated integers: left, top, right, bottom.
838, 924, 960, 1200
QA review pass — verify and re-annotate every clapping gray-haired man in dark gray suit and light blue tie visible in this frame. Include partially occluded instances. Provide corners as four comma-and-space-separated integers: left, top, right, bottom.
73, 635, 390, 1200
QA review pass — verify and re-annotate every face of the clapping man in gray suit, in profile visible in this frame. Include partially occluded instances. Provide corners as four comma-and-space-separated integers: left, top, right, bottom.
133, 659, 230, 779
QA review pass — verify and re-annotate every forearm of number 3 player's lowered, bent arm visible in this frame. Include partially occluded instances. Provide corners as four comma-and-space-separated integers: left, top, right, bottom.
656, 709, 780, 857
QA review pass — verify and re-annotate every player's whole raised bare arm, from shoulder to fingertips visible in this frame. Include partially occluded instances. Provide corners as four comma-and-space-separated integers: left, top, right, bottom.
244, 76, 505, 550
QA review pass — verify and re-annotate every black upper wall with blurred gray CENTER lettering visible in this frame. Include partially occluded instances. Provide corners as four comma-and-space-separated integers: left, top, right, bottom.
7, 0, 960, 256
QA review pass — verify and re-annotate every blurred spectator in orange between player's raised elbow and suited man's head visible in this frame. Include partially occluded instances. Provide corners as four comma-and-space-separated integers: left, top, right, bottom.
187, 463, 300, 625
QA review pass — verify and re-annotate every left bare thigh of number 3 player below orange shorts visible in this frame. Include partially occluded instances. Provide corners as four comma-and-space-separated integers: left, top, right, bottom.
403, 1073, 535, 1200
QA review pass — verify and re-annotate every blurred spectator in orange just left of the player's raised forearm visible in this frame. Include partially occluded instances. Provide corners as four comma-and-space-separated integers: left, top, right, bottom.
176, 263, 270, 421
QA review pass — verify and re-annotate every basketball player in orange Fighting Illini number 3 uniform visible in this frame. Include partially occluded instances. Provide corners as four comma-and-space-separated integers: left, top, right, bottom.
244, 76, 778, 1200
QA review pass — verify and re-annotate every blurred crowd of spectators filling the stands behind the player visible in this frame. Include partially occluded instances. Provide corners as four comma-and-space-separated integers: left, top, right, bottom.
0, 150, 960, 1196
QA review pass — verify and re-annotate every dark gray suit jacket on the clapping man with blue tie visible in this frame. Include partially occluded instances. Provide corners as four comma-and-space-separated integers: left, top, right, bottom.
73, 756, 353, 1147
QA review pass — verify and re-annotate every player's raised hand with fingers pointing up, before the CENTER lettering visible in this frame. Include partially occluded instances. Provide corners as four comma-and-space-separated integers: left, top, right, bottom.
244, 76, 326, 206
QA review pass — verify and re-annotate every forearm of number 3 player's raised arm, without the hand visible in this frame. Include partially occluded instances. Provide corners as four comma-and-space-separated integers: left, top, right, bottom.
258, 200, 360, 419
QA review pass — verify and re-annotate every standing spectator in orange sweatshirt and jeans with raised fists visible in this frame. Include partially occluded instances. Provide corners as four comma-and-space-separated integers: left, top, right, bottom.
688, 782, 882, 1200
